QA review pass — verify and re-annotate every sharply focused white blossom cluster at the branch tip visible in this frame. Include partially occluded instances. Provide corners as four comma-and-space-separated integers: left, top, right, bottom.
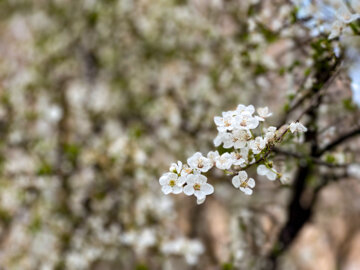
159, 104, 307, 204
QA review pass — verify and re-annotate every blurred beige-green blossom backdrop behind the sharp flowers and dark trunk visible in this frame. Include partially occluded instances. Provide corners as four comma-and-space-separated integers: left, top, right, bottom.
0, 0, 360, 270
